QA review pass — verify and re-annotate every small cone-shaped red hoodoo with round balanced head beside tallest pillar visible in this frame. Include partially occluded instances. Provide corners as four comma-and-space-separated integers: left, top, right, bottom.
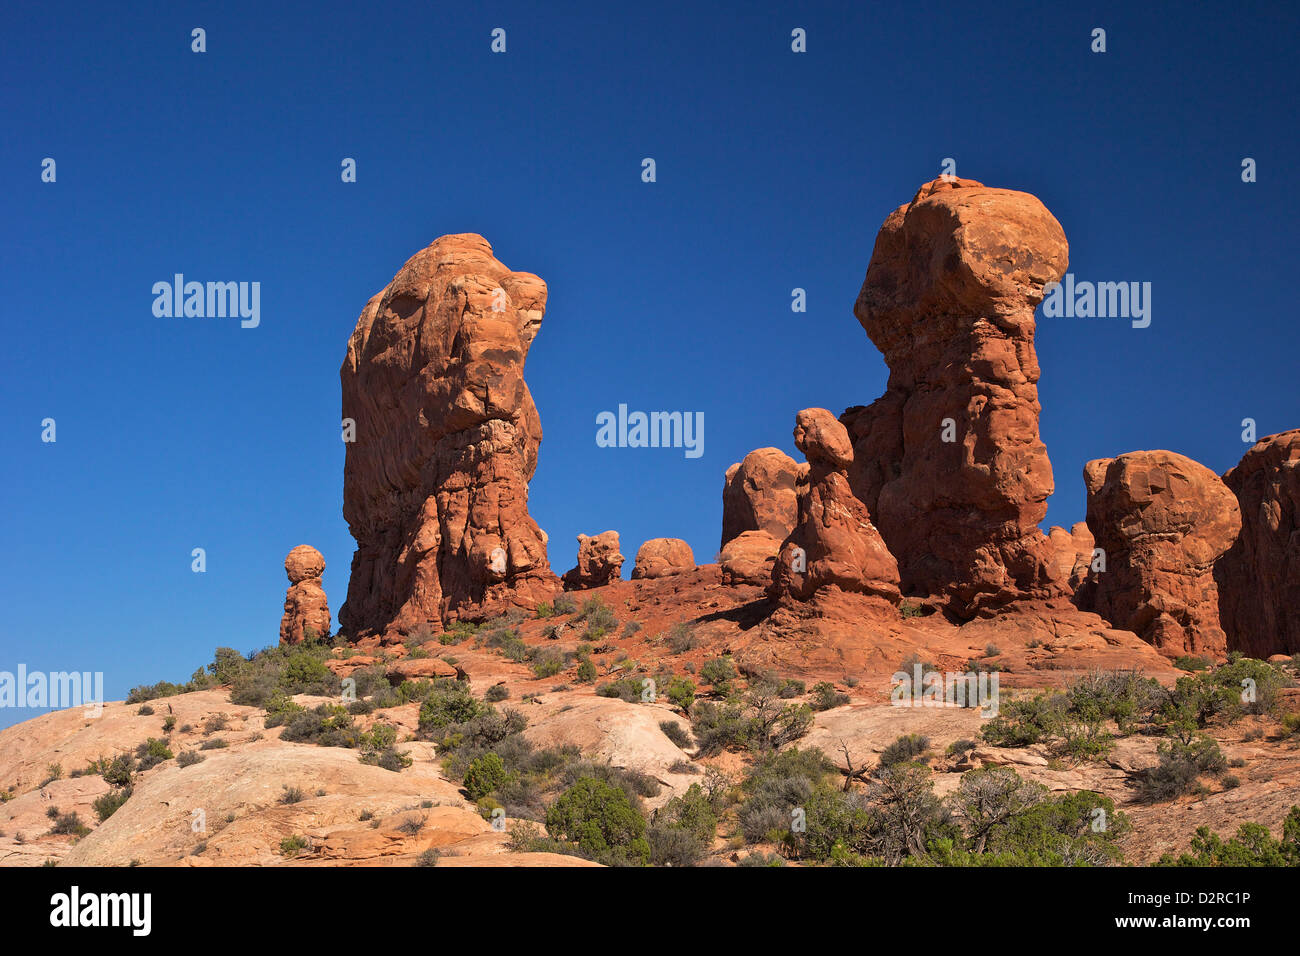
771, 408, 901, 605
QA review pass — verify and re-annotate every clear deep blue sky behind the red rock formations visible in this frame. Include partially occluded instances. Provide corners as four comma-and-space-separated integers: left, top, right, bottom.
0, 3, 1300, 723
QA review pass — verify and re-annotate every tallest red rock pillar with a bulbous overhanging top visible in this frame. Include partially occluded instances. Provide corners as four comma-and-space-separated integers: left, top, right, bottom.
841, 178, 1069, 617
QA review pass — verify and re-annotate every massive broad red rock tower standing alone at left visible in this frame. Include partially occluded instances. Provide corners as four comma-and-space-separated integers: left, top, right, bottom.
339, 234, 559, 637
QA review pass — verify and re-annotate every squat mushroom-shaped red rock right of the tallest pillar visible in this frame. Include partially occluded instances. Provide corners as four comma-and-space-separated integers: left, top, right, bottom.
1079, 451, 1242, 658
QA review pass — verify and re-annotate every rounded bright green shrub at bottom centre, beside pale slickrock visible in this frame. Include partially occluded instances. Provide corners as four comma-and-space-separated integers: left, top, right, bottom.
546, 778, 650, 866
